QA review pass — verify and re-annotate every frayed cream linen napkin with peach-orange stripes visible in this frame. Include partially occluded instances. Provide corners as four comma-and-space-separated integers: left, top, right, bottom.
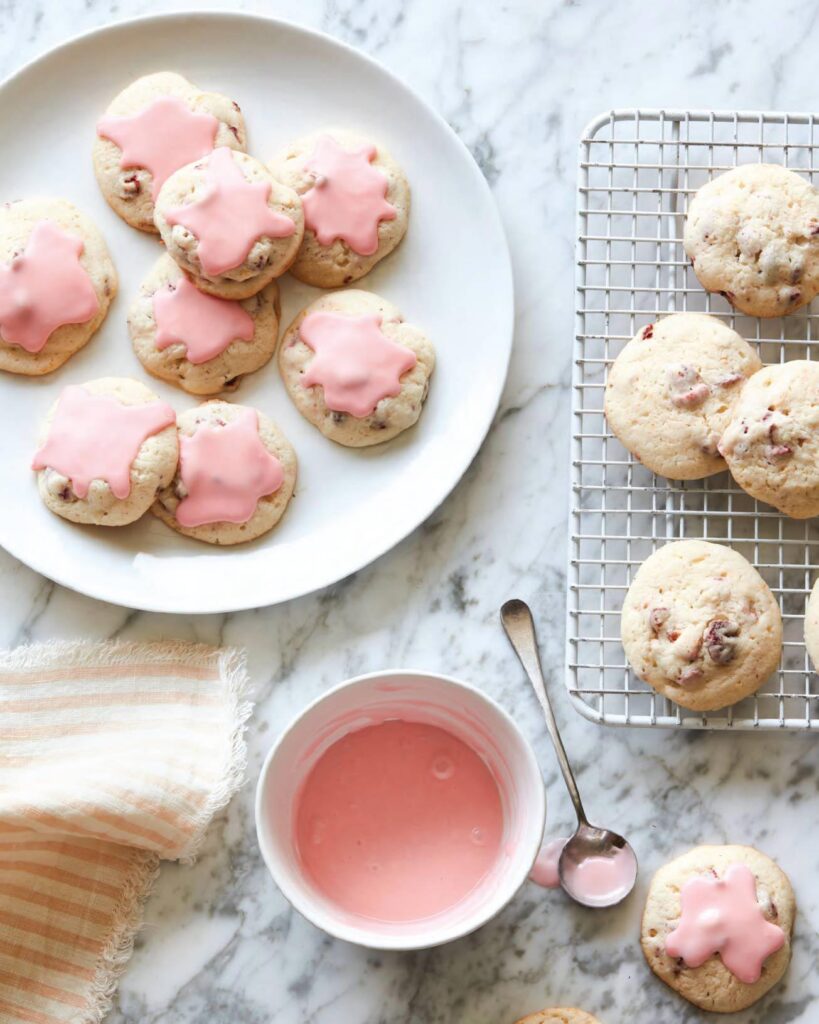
0, 643, 250, 1024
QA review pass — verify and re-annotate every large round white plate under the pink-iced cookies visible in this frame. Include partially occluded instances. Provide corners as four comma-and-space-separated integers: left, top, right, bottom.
0, 13, 513, 613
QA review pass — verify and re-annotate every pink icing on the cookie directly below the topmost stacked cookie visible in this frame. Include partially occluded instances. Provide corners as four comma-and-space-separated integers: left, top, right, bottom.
154, 278, 254, 366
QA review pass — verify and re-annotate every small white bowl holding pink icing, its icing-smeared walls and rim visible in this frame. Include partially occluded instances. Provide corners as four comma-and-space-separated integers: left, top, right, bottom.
256, 670, 546, 949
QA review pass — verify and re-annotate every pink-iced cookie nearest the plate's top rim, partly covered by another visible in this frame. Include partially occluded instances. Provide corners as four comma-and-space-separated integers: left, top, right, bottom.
93, 71, 247, 232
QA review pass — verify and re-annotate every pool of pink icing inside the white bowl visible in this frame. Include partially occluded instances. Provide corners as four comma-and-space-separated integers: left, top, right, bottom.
295, 720, 504, 922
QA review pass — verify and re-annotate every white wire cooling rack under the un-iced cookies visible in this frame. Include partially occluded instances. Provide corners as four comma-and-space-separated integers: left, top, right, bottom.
566, 110, 819, 729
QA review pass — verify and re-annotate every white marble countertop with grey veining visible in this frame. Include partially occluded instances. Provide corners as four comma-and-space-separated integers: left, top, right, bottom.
0, 0, 819, 1024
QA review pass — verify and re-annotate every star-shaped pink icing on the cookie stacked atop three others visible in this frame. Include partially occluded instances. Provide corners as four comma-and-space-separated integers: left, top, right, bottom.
165, 145, 296, 274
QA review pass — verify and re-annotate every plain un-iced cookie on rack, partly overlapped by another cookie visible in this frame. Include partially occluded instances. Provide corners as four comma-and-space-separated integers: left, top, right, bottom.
605, 313, 762, 480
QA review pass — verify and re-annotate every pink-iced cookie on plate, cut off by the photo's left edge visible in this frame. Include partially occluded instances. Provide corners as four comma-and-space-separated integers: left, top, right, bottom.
0, 199, 117, 376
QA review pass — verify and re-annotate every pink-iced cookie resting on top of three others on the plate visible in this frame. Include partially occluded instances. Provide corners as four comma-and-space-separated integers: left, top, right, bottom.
155, 146, 304, 299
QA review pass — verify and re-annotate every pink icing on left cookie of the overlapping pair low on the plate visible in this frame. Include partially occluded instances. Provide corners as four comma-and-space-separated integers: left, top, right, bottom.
32, 385, 176, 499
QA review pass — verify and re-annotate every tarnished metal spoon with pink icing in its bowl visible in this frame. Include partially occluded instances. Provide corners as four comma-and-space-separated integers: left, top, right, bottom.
501, 599, 637, 907
